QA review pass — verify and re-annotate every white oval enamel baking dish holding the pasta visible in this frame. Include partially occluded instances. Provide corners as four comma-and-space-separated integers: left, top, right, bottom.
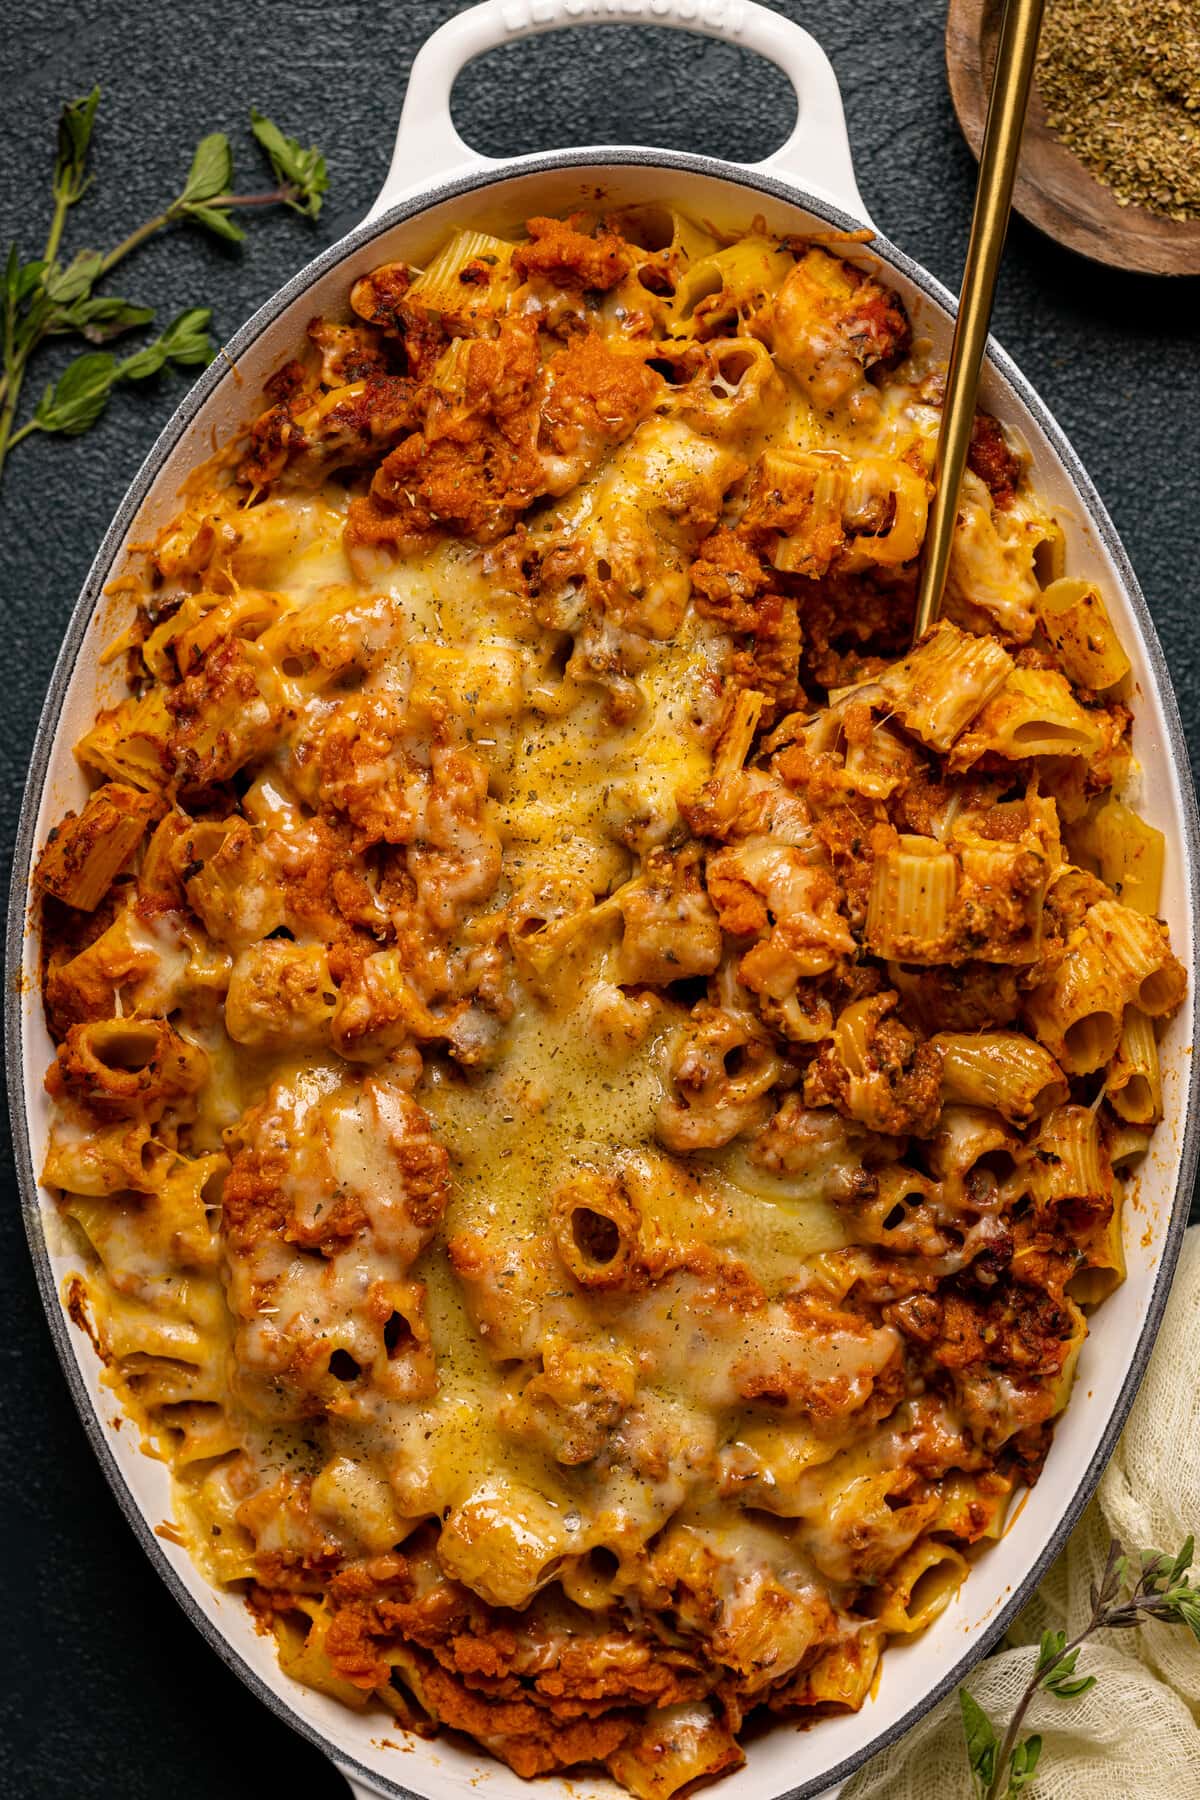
7, 0, 1200, 1800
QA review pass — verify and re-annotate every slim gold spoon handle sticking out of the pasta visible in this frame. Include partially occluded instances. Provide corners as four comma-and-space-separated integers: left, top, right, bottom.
912, 0, 1045, 643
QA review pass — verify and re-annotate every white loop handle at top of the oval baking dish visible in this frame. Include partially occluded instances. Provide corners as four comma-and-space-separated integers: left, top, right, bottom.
367, 0, 871, 223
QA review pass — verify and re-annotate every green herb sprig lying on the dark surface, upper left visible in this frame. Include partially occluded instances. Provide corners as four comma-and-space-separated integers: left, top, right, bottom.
0, 88, 327, 475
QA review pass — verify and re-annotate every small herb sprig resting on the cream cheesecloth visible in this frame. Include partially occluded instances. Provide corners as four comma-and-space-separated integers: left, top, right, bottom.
959, 1537, 1200, 1800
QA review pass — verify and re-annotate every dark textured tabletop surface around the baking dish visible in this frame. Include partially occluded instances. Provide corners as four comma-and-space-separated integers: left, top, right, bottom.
0, 0, 1200, 1800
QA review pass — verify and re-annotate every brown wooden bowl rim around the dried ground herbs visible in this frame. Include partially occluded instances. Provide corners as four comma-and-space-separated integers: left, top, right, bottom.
946, 0, 1200, 275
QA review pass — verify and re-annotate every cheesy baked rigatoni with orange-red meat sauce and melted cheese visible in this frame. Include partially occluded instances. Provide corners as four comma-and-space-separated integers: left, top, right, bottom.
38, 207, 1186, 1800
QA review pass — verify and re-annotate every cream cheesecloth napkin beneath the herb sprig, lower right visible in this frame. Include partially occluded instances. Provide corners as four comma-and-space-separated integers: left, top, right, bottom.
842, 1226, 1200, 1800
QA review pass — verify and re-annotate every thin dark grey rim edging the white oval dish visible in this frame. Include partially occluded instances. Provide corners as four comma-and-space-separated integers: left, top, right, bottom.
5, 148, 1200, 1800
